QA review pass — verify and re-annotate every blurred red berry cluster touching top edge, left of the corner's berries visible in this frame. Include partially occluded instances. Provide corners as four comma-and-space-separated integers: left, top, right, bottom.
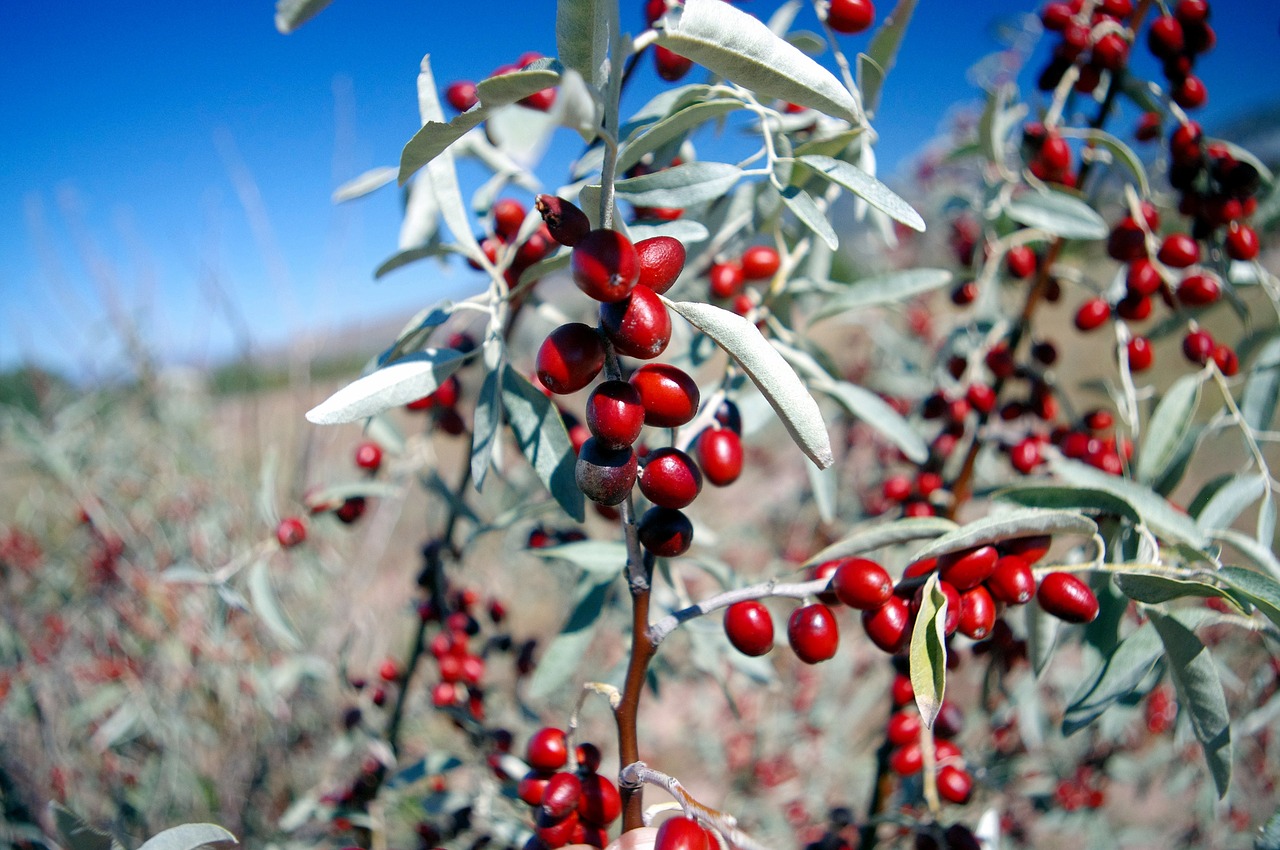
1037, 0, 1133, 101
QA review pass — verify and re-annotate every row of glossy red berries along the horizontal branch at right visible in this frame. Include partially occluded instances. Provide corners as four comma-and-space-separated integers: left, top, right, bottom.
724, 536, 1098, 664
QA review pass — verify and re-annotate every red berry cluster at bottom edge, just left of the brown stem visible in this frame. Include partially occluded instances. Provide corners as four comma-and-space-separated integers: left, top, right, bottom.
516, 726, 622, 850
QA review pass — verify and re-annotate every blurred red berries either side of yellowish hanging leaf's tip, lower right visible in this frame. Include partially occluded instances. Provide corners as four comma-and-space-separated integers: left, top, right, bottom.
884, 673, 973, 805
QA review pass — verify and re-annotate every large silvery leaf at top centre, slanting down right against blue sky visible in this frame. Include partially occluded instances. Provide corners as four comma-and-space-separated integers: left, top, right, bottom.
658, 0, 859, 120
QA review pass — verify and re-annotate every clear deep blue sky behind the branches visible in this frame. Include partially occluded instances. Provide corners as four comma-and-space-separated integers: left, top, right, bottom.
0, 0, 1280, 375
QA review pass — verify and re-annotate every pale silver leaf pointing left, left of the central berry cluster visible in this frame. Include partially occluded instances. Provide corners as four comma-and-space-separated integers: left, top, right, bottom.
307, 348, 466, 425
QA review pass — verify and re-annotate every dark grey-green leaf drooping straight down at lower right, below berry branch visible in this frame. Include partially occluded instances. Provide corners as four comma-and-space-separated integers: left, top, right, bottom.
1149, 611, 1231, 799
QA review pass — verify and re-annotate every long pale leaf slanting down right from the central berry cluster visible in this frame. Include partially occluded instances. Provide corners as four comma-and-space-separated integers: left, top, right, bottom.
663, 298, 835, 469
